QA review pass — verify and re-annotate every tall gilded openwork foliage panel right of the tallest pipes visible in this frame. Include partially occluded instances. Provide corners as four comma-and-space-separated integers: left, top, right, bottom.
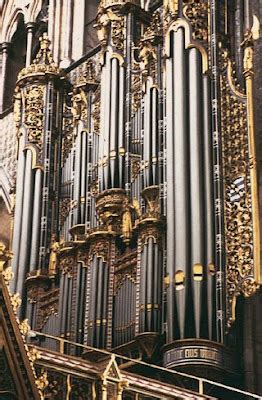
220, 48, 257, 326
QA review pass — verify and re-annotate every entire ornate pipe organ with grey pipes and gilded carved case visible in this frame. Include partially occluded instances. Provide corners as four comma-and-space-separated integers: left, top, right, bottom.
9, 0, 260, 379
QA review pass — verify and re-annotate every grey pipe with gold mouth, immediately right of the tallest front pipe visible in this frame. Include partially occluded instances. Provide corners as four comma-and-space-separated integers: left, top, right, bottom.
189, 48, 204, 338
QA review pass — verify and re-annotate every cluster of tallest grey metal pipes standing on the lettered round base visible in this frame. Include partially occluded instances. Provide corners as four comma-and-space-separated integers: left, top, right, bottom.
166, 27, 214, 342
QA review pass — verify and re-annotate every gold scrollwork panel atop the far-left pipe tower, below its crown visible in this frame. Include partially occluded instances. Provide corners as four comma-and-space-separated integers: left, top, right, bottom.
25, 85, 44, 145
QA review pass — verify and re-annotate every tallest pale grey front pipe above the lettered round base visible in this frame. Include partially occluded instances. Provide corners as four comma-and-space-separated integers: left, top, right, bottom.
173, 28, 189, 338
